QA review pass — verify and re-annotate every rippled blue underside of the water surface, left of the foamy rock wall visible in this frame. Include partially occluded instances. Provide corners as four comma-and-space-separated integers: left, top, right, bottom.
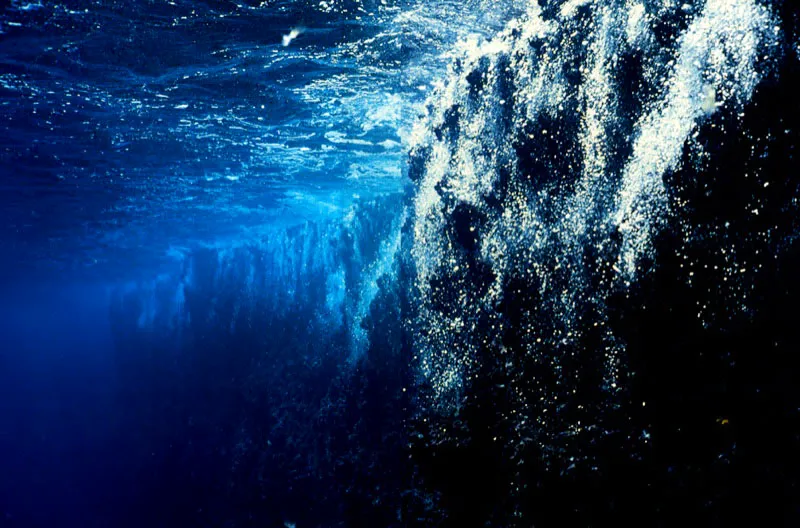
0, 1, 514, 276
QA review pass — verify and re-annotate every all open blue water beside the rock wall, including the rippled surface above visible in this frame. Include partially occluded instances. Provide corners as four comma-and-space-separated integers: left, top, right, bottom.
0, 1, 528, 526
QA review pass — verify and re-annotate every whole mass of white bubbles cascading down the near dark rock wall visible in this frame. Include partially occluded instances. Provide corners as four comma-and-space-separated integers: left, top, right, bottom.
409, 0, 775, 412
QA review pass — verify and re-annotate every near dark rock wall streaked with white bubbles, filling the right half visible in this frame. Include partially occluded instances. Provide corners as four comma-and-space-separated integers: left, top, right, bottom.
406, 0, 800, 526
